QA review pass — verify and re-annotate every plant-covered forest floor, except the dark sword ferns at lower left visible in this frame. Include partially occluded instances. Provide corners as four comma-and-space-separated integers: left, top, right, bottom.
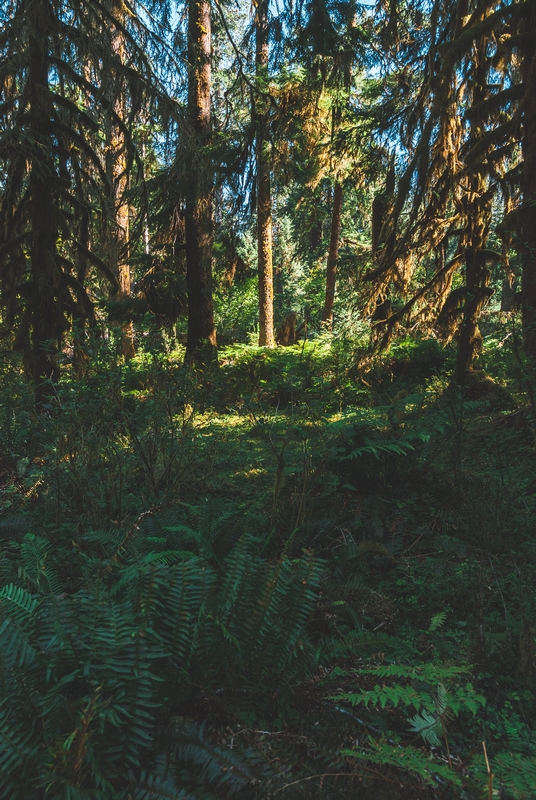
0, 330, 536, 800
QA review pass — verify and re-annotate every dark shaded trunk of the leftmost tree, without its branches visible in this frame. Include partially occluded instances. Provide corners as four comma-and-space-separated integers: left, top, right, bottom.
26, 0, 61, 406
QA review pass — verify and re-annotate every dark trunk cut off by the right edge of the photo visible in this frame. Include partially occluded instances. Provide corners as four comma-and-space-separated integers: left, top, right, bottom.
518, 0, 536, 364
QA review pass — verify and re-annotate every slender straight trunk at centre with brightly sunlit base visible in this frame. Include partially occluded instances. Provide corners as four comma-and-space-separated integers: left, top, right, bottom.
255, 0, 275, 347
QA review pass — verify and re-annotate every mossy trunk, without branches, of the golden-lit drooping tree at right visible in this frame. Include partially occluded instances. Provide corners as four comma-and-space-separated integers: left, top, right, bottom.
452, 38, 493, 383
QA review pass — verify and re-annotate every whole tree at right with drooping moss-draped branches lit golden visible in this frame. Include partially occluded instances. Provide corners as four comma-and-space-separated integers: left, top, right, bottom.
360, 2, 517, 382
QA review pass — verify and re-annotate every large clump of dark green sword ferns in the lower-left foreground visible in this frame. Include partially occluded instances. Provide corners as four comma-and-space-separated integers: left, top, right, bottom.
0, 526, 323, 798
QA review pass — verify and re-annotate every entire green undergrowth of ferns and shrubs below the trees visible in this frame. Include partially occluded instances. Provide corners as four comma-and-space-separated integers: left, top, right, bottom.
0, 318, 536, 800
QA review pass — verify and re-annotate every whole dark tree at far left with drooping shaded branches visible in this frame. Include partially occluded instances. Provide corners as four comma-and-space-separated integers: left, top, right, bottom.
0, 0, 158, 405
